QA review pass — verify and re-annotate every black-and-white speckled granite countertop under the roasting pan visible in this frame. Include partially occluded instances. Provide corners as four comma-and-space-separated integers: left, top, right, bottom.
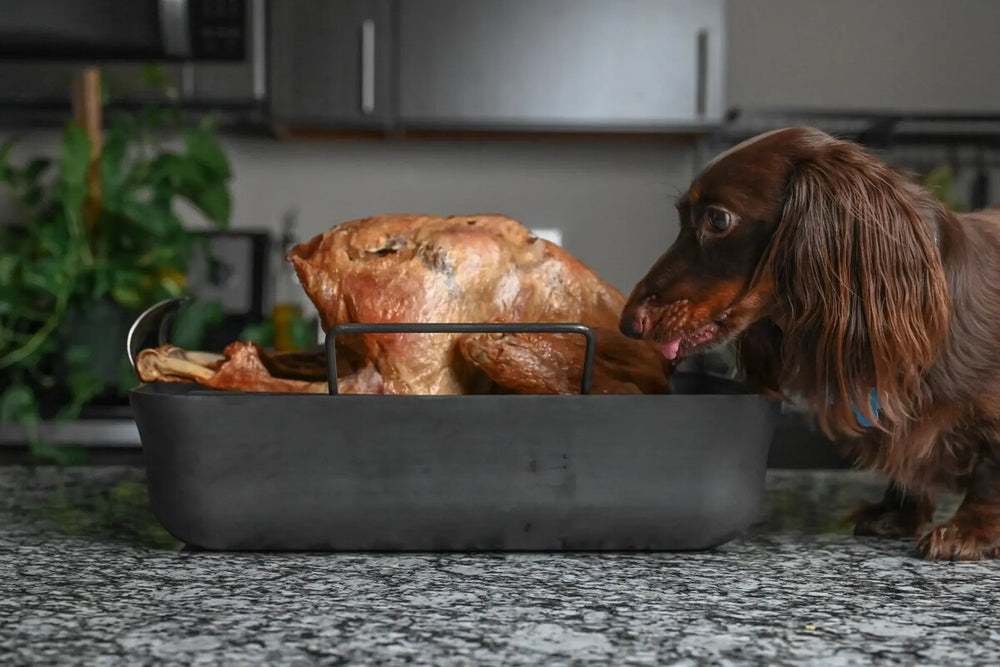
0, 467, 1000, 665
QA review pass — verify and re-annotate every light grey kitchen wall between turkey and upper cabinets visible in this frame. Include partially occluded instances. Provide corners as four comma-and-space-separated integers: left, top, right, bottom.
220, 139, 693, 291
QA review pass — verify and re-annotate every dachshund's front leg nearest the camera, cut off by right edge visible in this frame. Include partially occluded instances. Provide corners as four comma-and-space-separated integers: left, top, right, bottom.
917, 457, 1000, 560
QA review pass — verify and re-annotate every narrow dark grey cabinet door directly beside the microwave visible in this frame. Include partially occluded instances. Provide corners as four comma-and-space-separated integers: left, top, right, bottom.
269, 0, 392, 126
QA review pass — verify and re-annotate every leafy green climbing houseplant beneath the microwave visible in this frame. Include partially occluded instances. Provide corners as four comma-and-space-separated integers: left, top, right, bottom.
0, 90, 231, 460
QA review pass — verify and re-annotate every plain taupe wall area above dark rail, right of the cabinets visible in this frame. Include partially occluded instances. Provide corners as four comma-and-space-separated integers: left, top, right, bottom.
727, 0, 1000, 114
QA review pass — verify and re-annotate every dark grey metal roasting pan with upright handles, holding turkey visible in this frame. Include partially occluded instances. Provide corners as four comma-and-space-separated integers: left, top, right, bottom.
129, 300, 778, 551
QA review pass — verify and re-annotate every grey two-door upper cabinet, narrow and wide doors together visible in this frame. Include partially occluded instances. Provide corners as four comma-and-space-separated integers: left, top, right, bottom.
270, 0, 725, 131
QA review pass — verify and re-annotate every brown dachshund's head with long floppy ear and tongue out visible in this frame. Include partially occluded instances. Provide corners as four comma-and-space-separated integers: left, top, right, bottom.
621, 128, 948, 436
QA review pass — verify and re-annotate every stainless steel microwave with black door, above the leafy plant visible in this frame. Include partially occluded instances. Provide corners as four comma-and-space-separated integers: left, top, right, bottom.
0, 0, 267, 115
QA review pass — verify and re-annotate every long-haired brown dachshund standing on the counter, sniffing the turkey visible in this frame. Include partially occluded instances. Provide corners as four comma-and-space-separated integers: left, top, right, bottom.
621, 128, 1000, 560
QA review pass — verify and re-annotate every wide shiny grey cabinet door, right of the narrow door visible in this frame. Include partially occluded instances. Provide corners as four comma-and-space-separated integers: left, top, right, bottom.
398, 0, 725, 129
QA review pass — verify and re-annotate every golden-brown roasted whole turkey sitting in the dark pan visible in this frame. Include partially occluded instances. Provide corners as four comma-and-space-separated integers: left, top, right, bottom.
137, 215, 672, 394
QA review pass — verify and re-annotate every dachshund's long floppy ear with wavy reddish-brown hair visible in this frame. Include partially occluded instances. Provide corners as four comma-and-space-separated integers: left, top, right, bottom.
766, 139, 950, 435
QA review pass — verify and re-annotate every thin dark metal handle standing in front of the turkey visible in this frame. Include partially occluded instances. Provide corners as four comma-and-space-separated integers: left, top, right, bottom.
326, 322, 595, 396
